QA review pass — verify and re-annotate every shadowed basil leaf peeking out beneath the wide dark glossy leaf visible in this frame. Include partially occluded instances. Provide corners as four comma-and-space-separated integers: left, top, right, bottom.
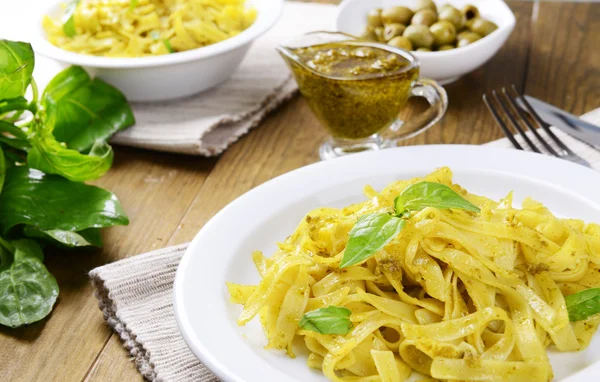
23, 226, 102, 248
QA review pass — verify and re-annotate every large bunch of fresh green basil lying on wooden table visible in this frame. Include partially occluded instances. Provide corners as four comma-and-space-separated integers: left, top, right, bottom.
0, 39, 134, 327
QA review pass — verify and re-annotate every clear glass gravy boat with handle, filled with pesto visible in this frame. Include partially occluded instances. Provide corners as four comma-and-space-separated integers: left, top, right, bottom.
277, 32, 448, 160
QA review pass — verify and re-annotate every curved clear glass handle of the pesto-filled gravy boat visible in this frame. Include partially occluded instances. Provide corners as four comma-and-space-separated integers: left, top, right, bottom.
384, 78, 448, 142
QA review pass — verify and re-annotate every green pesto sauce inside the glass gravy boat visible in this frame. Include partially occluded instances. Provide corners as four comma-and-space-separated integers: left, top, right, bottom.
286, 41, 419, 140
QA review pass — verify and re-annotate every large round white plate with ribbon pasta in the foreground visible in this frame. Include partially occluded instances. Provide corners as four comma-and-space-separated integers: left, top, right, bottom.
174, 145, 600, 382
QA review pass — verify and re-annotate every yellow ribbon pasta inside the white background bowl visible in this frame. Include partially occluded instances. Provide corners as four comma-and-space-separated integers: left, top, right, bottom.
43, 0, 256, 57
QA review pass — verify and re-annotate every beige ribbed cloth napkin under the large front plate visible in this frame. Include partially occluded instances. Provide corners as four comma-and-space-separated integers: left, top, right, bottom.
90, 109, 600, 382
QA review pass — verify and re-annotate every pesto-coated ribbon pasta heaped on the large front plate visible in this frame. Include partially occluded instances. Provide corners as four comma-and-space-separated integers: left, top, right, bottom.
228, 168, 600, 382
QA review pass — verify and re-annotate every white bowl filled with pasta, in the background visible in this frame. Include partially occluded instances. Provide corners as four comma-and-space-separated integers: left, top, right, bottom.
32, 0, 283, 101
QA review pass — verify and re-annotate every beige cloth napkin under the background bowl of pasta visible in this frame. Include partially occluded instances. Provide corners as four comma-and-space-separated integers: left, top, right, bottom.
111, 2, 335, 156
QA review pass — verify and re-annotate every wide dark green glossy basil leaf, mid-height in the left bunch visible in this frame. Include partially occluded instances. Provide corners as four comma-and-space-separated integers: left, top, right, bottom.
0, 167, 129, 232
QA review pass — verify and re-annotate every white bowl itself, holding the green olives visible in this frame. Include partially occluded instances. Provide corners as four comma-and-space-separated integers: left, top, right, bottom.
336, 0, 517, 84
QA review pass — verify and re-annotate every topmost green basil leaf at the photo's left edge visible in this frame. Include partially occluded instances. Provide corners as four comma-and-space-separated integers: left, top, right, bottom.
0, 39, 34, 100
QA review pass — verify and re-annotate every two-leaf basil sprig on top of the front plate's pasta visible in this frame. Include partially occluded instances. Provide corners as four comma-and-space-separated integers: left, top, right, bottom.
340, 182, 480, 268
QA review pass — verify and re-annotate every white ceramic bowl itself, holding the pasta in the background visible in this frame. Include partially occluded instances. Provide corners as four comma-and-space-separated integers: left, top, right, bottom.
32, 0, 283, 101
